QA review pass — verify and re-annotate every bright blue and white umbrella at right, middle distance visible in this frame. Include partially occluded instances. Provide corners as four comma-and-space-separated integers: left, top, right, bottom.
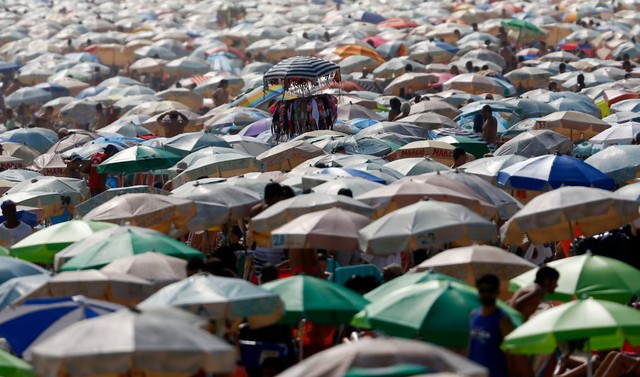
498, 155, 615, 191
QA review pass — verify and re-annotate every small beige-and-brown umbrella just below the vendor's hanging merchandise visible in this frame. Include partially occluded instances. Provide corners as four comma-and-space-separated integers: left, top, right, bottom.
256, 140, 324, 171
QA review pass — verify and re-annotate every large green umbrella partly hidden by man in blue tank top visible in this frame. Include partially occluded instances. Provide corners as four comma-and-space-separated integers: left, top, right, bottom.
352, 281, 522, 349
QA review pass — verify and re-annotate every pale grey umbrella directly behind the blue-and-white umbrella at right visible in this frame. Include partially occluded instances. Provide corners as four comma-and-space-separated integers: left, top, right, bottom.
494, 130, 573, 157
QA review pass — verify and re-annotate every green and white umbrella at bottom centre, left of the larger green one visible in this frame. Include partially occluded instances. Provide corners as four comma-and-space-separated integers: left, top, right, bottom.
262, 275, 369, 325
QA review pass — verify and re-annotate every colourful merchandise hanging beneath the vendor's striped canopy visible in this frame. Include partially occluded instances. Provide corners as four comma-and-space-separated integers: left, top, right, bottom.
269, 94, 338, 141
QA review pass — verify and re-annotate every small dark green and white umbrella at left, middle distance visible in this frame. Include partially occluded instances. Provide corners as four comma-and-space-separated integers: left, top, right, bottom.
98, 145, 182, 173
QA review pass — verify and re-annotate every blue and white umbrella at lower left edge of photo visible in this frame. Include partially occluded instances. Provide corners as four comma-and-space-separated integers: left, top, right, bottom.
0, 296, 124, 355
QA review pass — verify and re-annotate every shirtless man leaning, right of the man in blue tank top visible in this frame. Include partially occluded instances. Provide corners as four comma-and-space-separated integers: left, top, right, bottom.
509, 266, 560, 321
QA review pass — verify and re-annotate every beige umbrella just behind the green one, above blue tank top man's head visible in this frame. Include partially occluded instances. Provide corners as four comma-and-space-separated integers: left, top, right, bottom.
417, 245, 536, 284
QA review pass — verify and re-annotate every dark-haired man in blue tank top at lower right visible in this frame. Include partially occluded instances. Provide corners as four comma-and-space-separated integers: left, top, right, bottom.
468, 274, 513, 377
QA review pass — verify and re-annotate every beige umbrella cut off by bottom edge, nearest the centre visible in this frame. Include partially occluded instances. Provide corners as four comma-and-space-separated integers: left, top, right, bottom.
281, 338, 487, 377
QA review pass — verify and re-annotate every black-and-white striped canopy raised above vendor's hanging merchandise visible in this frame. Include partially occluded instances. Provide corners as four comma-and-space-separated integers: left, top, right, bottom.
263, 56, 341, 90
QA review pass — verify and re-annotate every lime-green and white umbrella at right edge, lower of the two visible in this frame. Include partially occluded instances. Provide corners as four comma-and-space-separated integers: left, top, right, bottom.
502, 298, 640, 354
